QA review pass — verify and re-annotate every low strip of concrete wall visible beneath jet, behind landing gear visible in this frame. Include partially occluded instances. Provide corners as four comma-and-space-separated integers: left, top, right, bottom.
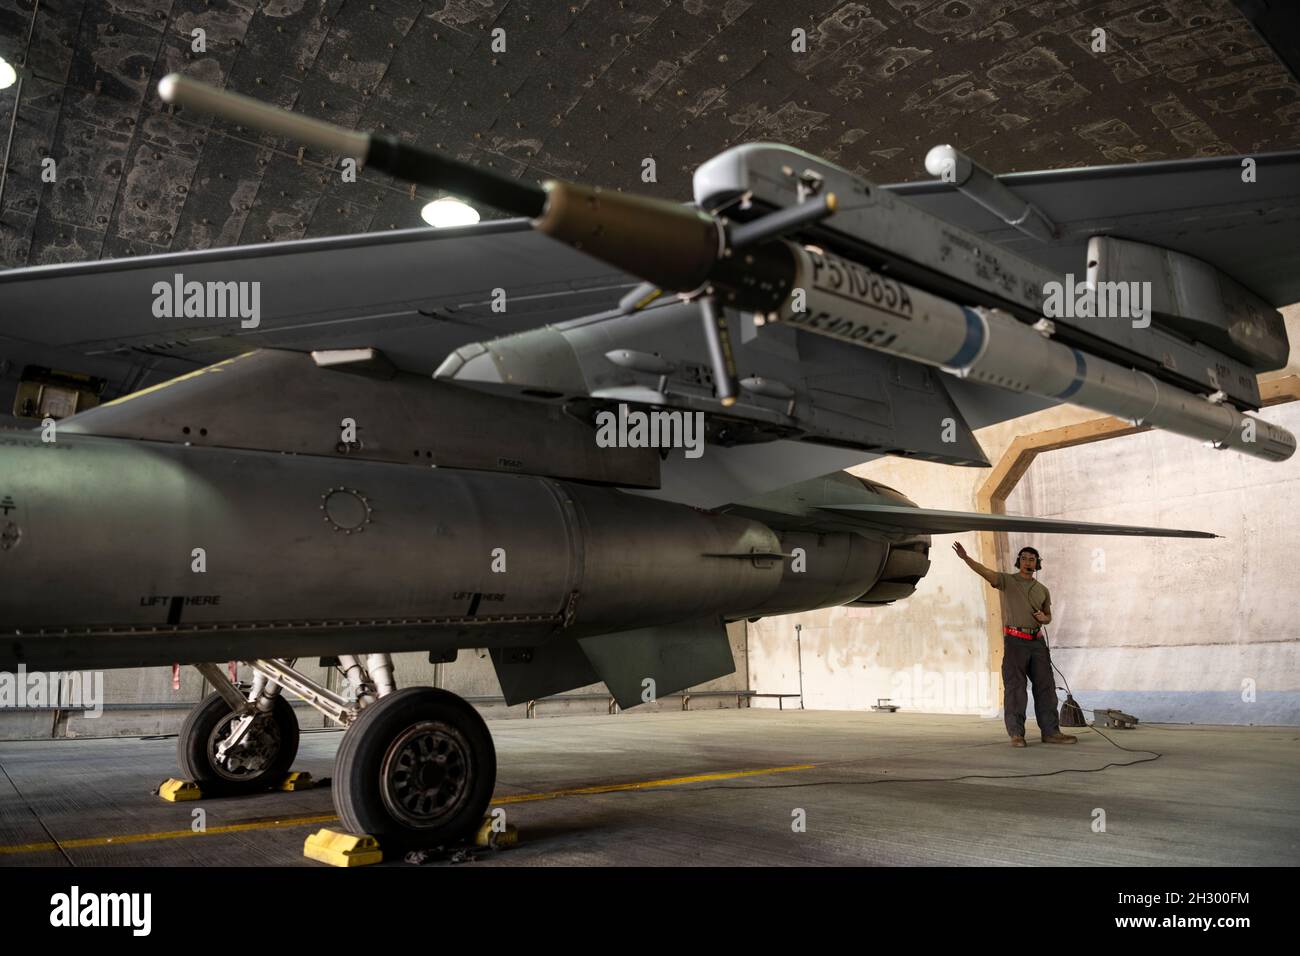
0, 622, 749, 740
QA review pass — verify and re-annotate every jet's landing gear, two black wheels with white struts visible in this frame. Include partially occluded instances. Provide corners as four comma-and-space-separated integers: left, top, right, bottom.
178, 654, 497, 851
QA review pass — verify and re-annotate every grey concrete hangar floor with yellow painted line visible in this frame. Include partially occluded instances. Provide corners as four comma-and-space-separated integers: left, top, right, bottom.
0, 709, 1300, 866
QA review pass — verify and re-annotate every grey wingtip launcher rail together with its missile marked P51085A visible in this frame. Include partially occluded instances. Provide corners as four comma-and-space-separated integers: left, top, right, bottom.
159, 74, 1296, 460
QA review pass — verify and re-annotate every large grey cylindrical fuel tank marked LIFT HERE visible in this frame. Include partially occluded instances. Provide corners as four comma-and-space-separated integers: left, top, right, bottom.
0, 433, 781, 667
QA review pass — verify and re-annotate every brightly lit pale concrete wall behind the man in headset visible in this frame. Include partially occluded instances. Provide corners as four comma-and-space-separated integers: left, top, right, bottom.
750, 306, 1300, 724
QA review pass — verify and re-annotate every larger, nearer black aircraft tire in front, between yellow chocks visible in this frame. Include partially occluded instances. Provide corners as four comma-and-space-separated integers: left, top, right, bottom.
333, 687, 497, 853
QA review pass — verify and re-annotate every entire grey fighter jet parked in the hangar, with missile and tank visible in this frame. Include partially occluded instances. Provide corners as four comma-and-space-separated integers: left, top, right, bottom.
0, 75, 1300, 849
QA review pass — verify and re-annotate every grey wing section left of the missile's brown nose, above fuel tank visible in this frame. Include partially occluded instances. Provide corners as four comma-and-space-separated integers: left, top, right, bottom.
0, 219, 634, 399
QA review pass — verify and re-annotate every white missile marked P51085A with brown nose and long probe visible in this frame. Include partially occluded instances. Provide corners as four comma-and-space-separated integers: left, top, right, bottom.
159, 74, 1296, 460
